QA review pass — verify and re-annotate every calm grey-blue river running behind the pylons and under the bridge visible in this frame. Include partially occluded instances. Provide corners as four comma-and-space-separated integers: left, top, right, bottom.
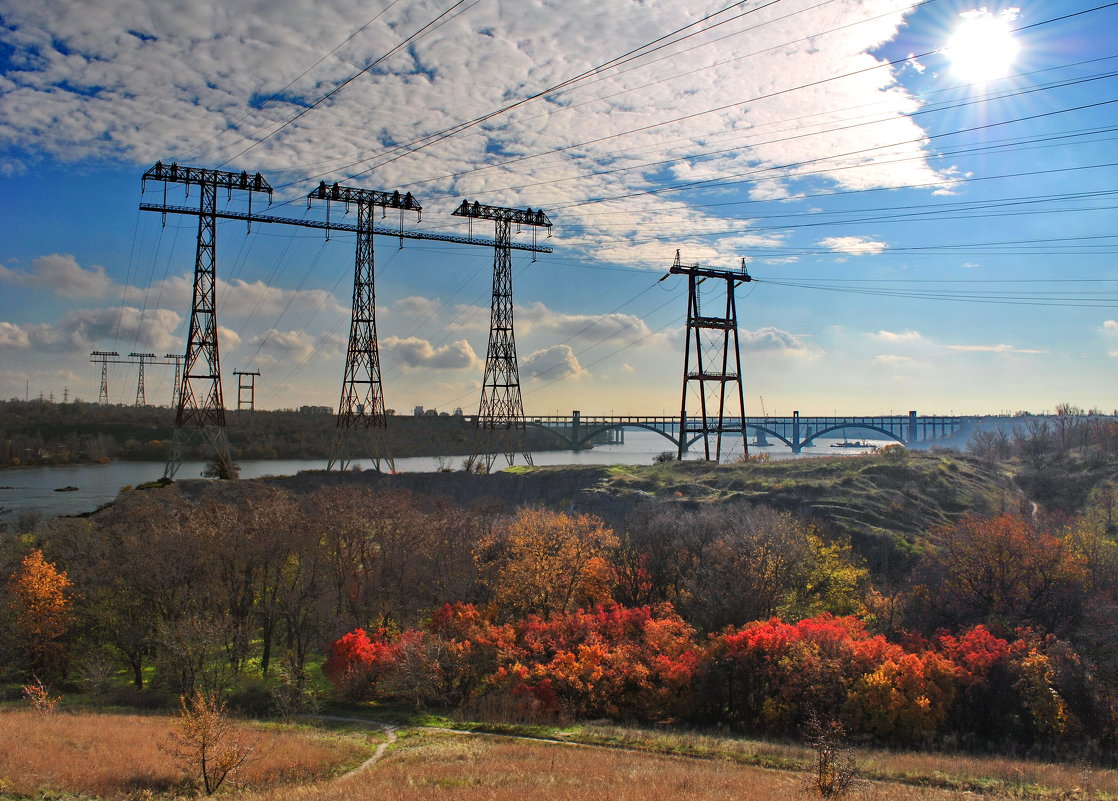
0, 430, 888, 525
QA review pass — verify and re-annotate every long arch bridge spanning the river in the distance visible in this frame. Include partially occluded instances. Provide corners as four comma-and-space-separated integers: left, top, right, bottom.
524, 411, 966, 453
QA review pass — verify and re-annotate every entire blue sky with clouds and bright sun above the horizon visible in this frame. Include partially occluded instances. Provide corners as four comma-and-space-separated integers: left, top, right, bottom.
0, 0, 1118, 414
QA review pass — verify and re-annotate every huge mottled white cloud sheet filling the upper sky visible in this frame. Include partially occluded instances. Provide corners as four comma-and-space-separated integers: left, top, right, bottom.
0, 0, 951, 264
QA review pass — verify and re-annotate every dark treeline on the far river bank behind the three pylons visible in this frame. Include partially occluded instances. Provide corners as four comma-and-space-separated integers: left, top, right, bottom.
0, 401, 576, 468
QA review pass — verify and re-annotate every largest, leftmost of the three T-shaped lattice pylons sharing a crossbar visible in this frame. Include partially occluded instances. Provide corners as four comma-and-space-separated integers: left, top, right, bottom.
141, 161, 272, 479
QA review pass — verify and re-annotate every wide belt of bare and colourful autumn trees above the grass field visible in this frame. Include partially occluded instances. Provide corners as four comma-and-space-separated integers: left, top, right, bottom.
0, 465, 1118, 743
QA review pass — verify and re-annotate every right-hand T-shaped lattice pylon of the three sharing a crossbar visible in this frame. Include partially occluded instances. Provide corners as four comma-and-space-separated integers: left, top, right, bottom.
453, 200, 551, 472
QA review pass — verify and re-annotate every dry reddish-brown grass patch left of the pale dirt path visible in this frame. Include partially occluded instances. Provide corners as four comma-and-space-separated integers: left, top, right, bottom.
0, 709, 369, 799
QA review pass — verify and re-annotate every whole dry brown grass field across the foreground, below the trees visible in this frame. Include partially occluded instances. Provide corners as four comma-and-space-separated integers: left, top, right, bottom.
0, 708, 1118, 801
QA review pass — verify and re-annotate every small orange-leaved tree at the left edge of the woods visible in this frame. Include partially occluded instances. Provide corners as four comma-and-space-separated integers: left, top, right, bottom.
9, 548, 73, 678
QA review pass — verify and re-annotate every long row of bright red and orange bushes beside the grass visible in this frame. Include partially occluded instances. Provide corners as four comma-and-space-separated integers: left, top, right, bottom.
323, 604, 1083, 742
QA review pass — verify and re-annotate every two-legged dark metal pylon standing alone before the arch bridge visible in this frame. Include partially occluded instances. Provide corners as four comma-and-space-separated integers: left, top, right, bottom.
661, 251, 752, 462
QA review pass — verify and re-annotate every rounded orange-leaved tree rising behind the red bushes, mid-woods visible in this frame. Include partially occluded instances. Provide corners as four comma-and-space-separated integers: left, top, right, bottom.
474, 508, 617, 616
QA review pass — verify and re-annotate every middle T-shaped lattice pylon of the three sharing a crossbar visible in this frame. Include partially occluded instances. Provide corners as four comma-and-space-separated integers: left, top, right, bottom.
306, 181, 423, 471
